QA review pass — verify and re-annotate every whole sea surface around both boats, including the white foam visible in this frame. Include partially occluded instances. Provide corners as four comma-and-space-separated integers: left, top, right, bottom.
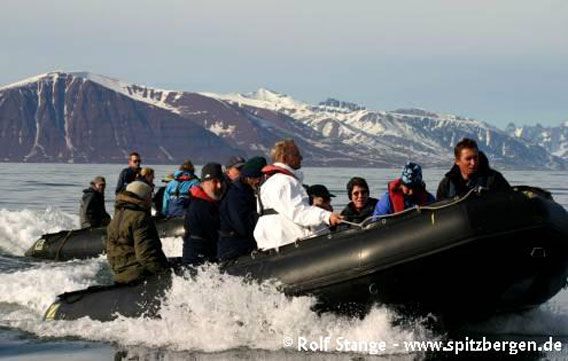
0, 163, 568, 360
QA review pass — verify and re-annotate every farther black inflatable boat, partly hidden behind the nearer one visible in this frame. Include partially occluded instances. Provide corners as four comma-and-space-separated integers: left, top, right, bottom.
25, 218, 185, 261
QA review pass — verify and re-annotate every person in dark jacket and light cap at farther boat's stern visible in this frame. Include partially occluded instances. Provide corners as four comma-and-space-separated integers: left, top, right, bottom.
79, 176, 110, 228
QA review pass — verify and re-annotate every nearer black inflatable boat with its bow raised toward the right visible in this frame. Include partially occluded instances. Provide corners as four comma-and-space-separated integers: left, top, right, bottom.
45, 187, 568, 320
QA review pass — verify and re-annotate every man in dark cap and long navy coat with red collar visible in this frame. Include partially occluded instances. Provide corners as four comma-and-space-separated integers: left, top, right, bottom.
182, 163, 225, 265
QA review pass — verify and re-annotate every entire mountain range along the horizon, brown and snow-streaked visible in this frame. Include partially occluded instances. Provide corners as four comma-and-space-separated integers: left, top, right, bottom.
0, 72, 568, 169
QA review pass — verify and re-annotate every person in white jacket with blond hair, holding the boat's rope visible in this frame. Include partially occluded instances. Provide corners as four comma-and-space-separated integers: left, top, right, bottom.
254, 139, 342, 250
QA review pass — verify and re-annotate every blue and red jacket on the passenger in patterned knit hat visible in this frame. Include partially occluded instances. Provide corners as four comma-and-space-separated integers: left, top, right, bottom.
373, 178, 436, 216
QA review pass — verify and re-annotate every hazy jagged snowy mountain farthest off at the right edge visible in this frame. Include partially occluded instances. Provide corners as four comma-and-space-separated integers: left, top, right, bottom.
507, 121, 568, 159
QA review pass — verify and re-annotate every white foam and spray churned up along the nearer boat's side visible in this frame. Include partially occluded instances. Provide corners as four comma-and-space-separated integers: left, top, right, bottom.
0, 259, 432, 352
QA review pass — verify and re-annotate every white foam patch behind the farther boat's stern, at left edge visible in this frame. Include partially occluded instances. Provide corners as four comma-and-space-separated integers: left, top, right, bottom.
0, 207, 79, 256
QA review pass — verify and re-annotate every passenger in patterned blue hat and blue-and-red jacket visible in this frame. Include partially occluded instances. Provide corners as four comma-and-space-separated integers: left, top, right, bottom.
373, 162, 435, 216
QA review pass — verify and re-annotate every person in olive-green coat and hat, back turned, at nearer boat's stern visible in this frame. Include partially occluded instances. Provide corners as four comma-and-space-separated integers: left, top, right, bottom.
107, 181, 169, 283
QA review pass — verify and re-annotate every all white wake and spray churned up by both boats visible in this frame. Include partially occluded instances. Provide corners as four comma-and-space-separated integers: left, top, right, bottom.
0, 208, 568, 352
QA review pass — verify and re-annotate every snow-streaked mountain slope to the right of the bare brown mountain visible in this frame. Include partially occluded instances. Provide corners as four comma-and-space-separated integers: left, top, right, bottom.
204, 89, 566, 169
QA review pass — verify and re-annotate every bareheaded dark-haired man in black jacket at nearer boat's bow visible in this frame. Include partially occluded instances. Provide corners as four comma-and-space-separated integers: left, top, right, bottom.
436, 138, 511, 200
